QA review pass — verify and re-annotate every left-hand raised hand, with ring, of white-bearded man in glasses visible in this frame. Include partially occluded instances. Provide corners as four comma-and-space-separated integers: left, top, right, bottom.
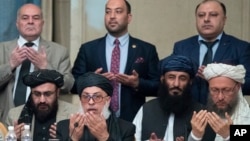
69, 113, 85, 141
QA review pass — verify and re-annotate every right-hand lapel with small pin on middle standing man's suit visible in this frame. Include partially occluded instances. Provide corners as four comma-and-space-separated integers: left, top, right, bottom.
124, 36, 137, 74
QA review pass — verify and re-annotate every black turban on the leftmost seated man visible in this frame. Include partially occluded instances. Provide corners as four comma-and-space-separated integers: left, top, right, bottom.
23, 69, 64, 88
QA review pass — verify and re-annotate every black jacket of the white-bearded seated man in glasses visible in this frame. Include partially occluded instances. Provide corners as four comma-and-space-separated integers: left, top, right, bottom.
57, 117, 135, 141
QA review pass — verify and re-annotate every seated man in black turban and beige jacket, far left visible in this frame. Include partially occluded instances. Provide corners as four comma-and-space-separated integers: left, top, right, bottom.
6, 69, 78, 141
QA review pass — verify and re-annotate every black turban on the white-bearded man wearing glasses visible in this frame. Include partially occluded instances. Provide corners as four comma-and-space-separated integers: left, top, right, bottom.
76, 72, 113, 96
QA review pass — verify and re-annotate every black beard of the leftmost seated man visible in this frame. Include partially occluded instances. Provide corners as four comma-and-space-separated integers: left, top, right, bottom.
31, 99, 58, 123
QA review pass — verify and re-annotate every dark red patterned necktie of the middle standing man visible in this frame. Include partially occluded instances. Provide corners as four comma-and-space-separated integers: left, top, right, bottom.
110, 39, 120, 112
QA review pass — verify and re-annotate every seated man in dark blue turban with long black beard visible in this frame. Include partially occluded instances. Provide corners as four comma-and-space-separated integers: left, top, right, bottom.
133, 55, 202, 141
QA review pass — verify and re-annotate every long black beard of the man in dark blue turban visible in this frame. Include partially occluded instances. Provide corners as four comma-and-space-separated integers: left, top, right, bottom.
158, 81, 192, 116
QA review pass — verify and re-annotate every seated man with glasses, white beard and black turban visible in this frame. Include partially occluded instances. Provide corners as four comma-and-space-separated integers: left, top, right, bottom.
57, 72, 135, 141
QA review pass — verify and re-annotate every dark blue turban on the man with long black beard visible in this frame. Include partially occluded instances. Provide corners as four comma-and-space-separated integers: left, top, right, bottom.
160, 55, 195, 78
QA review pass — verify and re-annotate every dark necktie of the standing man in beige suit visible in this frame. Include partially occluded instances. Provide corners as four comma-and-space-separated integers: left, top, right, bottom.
14, 42, 34, 106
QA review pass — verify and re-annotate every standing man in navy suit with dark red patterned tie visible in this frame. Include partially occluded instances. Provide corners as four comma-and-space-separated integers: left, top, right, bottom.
72, 0, 160, 121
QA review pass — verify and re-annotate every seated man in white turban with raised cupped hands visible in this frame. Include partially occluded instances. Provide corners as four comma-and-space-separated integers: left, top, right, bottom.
189, 63, 250, 141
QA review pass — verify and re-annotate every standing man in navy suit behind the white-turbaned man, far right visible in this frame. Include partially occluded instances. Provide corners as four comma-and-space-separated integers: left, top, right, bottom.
173, 0, 250, 104
